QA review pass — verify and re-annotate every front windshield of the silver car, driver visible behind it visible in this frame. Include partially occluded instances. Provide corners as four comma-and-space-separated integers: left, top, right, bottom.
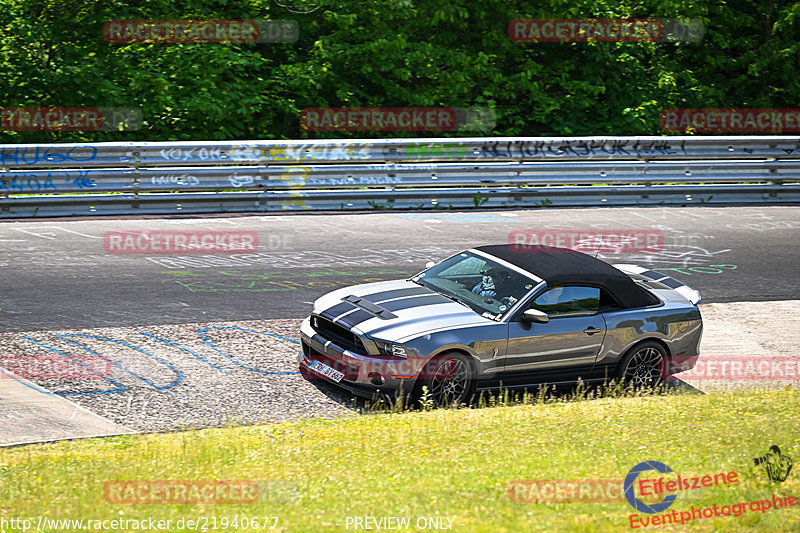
412, 252, 536, 320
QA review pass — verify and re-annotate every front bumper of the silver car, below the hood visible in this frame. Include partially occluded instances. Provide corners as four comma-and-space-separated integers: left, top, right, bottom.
297, 318, 423, 398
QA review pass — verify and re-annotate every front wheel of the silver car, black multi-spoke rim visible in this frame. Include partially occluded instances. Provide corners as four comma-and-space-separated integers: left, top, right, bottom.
415, 352, 475, 407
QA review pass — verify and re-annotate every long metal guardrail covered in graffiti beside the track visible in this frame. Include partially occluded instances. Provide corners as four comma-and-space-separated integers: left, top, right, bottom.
0, 136, 800, 218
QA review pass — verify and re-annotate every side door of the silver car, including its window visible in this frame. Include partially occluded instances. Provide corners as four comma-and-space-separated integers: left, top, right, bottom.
503, 285, 606, 386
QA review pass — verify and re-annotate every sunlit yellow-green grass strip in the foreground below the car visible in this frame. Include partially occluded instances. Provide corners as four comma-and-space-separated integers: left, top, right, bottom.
0, 390, 800, 532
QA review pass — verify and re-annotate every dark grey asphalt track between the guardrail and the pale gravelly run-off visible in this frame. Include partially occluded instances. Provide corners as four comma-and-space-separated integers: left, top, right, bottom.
0, 207, 800, 332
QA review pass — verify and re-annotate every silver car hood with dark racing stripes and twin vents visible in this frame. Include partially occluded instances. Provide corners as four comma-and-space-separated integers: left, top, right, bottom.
313, 280, 496, 342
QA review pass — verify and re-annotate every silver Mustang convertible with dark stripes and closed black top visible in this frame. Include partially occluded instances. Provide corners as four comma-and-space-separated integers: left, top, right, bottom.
298, 245, 703, 405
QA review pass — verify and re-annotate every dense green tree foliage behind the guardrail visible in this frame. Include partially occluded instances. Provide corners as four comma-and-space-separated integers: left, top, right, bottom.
0, 0, 800, 142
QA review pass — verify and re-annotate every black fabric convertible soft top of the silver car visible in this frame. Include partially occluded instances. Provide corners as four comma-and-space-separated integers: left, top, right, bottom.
474, 244, 659, 308
